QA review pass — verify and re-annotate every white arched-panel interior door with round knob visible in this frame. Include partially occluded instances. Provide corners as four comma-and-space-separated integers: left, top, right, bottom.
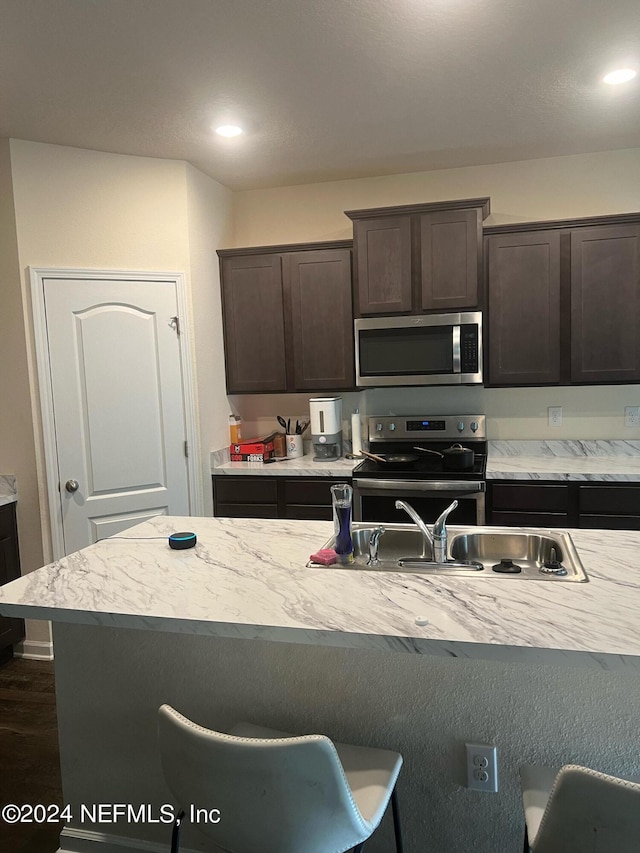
43, 278, 189, 554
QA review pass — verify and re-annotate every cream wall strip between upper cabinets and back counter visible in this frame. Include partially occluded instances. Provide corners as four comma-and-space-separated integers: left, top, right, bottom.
229, 385, 640, 441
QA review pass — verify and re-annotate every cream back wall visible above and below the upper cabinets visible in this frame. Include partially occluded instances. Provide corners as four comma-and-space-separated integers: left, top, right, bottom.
234, 148, 640, 439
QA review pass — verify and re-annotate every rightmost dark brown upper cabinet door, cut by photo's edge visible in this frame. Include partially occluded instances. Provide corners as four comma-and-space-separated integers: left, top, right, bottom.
571, 225, 640, 382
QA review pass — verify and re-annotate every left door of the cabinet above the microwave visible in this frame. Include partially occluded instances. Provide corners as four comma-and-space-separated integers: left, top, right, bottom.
354, 215, 412, 314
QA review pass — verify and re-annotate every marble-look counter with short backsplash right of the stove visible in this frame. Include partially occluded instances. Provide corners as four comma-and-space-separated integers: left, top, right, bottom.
487, 440, 640, 482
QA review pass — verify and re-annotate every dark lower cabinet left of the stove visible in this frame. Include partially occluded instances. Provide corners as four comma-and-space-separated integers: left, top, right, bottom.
211, 474, 351, 521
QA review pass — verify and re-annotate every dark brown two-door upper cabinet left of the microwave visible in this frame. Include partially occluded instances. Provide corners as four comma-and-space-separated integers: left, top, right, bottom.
218, 241, 355, 394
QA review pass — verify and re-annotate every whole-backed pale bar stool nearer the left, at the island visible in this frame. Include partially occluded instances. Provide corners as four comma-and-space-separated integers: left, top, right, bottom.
158, 705, 402, 853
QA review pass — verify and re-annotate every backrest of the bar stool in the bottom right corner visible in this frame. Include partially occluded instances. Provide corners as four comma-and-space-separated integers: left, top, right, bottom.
532, 764, 640, 853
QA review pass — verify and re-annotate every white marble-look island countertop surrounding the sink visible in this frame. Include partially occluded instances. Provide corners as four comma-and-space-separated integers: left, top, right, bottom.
0, 516, 640, 669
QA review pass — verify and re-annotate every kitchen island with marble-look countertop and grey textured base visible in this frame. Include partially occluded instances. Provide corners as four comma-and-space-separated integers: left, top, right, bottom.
0, 516, 640, 853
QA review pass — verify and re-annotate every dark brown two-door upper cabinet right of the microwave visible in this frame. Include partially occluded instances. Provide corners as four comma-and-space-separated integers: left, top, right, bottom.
485, 214, 640, 385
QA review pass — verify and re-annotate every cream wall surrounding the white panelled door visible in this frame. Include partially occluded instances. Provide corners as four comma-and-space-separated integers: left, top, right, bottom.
2, 140, 230, 638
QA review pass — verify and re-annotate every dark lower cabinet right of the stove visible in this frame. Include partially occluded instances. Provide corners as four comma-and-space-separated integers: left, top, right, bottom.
487, 480, 640, 530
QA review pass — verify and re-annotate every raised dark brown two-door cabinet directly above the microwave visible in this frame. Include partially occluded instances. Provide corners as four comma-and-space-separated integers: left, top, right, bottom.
345, 198, 489, 315
